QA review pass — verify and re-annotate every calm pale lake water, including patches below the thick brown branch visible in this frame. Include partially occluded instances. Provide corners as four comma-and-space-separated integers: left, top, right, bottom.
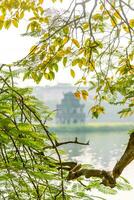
53, 127, 134, 200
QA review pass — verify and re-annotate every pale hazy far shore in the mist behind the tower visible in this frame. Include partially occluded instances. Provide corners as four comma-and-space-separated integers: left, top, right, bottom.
33, 83, 134, 123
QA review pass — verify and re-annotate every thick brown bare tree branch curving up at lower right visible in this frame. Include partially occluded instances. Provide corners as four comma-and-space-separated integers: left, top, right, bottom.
66, 132, 134, 188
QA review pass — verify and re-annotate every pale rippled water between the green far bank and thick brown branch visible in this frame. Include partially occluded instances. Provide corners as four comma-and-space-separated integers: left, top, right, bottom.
58, 131, 129, 168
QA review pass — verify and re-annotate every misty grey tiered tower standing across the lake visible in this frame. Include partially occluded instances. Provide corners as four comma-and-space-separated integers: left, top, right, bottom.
56, 92, 86, 124
